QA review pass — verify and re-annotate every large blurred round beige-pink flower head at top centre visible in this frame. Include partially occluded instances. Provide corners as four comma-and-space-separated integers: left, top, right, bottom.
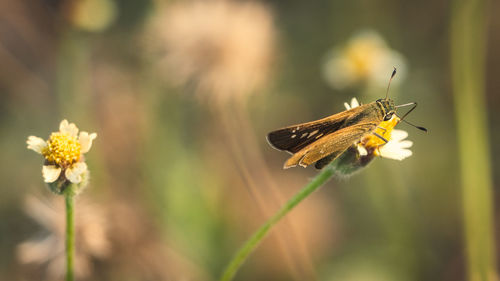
155, 1, 275, 101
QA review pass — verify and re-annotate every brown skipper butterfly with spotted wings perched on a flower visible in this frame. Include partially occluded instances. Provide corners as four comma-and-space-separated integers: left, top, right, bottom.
267, 68, 427, 169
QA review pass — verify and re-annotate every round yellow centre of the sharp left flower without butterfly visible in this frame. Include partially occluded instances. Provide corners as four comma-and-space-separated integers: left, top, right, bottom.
42, 132, 81, 167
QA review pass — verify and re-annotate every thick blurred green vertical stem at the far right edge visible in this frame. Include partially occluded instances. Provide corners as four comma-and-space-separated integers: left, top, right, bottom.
450, 0, 497, 281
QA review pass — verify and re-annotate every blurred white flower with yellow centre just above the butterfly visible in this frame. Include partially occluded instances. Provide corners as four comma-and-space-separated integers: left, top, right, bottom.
323, 31, 406, 89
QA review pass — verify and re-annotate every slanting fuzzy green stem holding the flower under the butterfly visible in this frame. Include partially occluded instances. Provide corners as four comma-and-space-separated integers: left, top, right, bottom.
220, 165, 334, 281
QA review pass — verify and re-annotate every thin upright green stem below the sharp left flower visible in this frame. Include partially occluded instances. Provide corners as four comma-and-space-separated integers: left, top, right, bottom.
64, 192, 75, 281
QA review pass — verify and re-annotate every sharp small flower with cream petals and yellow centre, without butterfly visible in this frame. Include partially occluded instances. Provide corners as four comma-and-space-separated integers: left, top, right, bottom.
26, 120, 97, 184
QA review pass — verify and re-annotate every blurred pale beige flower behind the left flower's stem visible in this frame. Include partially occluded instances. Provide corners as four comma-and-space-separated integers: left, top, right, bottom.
16, 196, 111, 280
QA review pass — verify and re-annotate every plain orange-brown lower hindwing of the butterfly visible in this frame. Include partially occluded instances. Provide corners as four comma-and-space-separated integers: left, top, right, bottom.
284, 122, 377, 169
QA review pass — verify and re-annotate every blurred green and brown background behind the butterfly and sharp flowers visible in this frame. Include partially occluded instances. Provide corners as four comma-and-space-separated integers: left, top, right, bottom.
0, 0, 500, 281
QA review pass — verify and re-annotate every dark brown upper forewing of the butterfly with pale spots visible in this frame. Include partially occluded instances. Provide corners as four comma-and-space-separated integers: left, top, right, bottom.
267, 105, 367, 154
